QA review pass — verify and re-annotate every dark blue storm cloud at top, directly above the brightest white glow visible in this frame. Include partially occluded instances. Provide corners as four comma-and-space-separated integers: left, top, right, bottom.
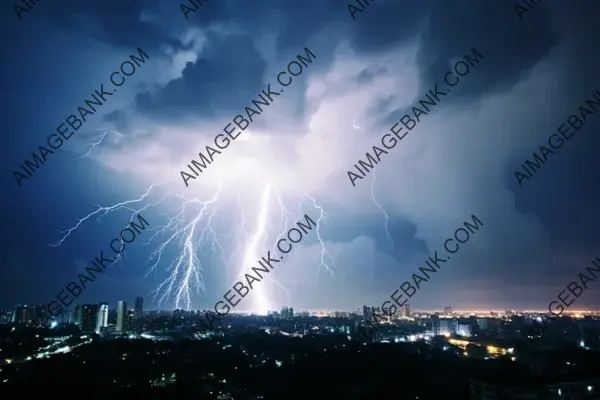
129, 1, 344, 123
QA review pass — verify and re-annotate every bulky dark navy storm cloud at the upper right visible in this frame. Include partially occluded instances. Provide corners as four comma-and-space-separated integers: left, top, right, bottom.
370, 0, 557, 124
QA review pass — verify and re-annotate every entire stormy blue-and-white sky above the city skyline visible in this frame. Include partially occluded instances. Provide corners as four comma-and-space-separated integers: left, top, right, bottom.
0, 0, 600, 310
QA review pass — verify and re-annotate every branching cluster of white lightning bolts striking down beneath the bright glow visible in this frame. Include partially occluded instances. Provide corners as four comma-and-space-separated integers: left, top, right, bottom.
51, 183, 335, 314
